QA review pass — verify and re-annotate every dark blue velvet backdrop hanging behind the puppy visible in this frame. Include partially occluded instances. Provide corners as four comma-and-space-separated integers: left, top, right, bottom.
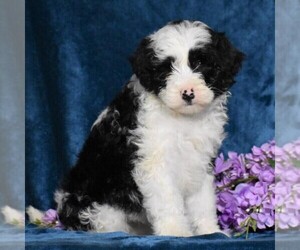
26, 0, 274, 249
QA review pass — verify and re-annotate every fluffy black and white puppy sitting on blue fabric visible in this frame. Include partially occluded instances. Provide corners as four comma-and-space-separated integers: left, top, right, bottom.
55, 21, 244, 236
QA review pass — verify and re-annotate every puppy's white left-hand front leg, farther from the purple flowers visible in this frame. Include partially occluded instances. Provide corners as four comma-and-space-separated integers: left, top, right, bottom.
134, 165, 192, 236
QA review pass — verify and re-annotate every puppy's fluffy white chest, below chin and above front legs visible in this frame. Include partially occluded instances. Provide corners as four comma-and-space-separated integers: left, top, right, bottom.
134, 94, 225, 193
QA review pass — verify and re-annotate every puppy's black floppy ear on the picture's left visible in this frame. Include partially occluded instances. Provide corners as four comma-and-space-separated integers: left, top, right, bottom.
129, 37, 155, 90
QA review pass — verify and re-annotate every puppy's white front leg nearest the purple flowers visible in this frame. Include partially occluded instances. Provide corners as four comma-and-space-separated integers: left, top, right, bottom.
186, 174, 221, 235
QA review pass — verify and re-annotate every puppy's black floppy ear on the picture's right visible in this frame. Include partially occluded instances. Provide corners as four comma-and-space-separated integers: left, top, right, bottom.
212, 32, 245, 87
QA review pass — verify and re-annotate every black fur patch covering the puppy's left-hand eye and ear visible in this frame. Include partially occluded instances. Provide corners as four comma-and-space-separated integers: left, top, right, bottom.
130, 37, 174, 95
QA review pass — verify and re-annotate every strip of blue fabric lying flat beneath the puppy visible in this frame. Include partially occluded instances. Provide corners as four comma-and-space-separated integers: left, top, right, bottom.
26, 228, 274, 250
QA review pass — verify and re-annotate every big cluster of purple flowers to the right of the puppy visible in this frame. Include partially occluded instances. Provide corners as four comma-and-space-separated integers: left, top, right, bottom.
215, 140, 300, 232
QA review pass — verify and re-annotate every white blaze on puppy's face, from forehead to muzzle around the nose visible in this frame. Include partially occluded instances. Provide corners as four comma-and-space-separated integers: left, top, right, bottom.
150, 22, 214, 114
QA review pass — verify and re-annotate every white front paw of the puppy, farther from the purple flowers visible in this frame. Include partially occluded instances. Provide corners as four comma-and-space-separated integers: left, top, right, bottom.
155, 219, 193, 237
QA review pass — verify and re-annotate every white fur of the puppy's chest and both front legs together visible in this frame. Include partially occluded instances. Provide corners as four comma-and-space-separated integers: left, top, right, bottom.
132, 81, 227, 236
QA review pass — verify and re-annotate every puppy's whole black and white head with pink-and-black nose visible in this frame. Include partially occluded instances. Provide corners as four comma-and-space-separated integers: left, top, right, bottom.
131, 21, 244, 114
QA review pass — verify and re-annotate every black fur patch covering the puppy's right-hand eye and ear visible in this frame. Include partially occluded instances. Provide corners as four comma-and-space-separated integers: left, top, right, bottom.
189, 30, 244, 97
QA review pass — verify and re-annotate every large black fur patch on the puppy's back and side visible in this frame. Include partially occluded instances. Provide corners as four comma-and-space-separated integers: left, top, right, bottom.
59, 85, 142, 230
